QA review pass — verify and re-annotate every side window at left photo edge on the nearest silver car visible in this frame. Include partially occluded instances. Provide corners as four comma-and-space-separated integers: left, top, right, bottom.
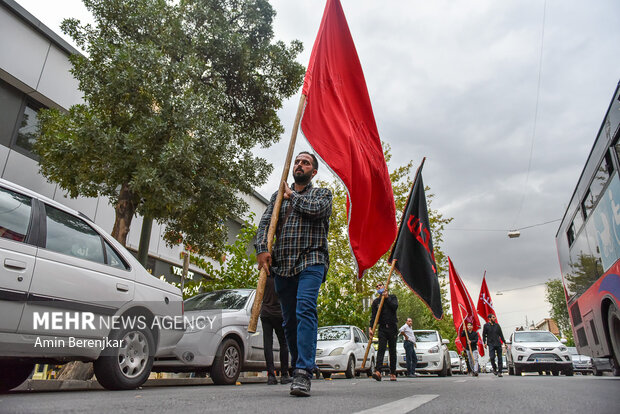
0, 188, 32, 243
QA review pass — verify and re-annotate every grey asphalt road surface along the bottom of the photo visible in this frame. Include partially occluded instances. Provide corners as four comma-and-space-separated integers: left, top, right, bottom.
0, 374, 620, 414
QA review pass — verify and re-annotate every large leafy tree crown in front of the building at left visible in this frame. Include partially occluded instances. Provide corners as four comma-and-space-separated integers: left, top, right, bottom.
35, 0, 304, 256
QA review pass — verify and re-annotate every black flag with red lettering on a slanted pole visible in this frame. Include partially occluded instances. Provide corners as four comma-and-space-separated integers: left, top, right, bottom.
388, 158, 443, 319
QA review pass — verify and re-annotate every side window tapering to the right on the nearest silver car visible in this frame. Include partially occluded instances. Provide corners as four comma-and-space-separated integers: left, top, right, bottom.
45, 205, 105, 263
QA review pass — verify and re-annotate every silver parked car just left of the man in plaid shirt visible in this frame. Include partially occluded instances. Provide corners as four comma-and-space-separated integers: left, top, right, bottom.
153, 289, 280, 385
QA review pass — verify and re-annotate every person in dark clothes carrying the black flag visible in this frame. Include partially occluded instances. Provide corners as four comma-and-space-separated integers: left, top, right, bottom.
369, 282, 398, 381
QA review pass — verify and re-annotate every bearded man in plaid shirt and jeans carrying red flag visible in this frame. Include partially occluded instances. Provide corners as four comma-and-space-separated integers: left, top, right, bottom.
255, 151, 332, 396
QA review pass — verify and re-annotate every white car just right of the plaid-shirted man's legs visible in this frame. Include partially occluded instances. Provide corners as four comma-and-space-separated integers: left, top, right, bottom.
316, 325, 376, 378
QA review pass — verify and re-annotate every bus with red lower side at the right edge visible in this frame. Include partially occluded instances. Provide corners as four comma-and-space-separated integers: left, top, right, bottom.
555, 83, 620, 375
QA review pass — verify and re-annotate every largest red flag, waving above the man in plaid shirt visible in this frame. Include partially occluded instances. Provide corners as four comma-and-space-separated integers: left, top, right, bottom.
301, 0, 396, 278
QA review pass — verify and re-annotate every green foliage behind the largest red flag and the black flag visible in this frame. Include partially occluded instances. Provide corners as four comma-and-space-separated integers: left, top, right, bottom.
317, 145, 456, 339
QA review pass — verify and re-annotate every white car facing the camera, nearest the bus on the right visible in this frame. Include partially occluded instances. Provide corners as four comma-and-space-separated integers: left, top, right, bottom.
506, 330, 573, 376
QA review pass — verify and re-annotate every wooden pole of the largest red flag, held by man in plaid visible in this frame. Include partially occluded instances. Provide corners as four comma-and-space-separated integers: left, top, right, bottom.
248, 94, 306, 333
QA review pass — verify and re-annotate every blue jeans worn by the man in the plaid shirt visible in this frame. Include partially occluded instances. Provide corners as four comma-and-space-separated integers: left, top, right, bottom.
274, 265, 325, 374
